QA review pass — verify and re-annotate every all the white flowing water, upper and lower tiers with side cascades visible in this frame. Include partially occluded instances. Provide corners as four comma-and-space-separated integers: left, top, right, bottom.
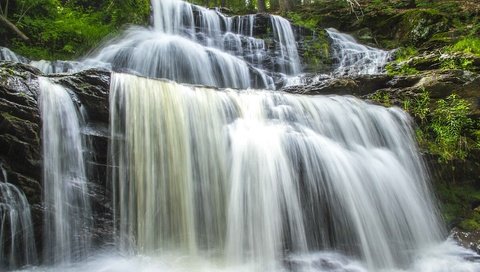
0, 0, 480, 272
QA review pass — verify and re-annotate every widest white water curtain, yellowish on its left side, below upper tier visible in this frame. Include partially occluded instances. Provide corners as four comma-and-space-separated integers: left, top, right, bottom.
110, 74, 443, 271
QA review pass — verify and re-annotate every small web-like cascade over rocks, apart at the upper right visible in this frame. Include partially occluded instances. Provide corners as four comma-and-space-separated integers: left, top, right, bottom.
326, 28, 391, 75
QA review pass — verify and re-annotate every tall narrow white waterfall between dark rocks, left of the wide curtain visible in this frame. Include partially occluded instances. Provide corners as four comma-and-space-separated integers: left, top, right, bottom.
39, 78, 92, 263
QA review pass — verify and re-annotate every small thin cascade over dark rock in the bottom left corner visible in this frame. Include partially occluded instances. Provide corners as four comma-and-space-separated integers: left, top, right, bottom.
0, 165, 37, 270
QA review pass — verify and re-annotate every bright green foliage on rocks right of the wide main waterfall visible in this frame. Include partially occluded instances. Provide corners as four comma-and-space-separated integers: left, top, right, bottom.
370, 89, 480, 164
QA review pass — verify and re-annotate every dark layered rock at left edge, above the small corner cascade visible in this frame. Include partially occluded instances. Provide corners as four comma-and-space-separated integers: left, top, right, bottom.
0, 62, 42, 204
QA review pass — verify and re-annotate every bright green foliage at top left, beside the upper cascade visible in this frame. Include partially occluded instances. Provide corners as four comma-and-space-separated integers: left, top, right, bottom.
8, 0, 150, 59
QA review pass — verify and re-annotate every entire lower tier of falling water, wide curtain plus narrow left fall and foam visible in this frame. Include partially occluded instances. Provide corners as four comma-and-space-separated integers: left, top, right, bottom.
0, 73, 480, 272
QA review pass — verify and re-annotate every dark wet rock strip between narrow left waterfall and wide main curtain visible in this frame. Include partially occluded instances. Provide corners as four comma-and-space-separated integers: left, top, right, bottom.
51, 69, 114, 245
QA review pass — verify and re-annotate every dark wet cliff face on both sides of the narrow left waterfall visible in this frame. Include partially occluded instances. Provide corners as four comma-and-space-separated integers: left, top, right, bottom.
0, 62, 113, 260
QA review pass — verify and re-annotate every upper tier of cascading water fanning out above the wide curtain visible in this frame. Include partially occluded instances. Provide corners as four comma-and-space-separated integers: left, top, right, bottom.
80, 0, 301, 89
